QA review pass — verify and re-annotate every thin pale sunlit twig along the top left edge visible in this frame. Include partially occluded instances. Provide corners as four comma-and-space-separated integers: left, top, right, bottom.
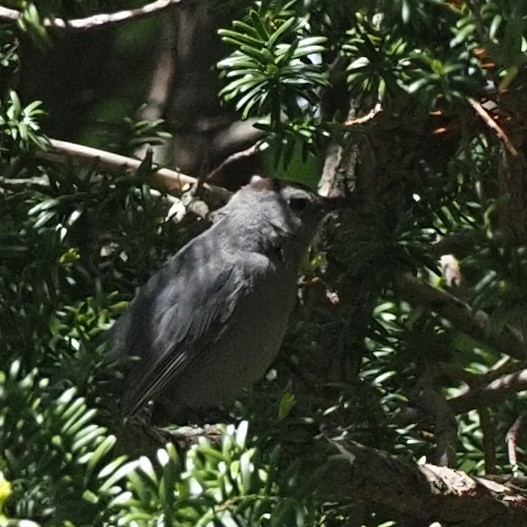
0, 0, 188, 31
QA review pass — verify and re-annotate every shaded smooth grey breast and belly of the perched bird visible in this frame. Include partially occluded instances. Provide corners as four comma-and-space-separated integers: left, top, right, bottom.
162, 264, 296, 409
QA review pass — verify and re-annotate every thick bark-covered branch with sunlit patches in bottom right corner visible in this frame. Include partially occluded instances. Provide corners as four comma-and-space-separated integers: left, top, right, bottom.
332, 442, 527, 527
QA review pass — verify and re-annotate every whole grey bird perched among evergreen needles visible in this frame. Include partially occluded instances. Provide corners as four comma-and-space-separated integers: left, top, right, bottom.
110, 179, 334, 424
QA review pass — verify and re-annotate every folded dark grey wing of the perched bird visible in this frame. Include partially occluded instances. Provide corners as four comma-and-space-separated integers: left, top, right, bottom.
118, 252, 253, 417
